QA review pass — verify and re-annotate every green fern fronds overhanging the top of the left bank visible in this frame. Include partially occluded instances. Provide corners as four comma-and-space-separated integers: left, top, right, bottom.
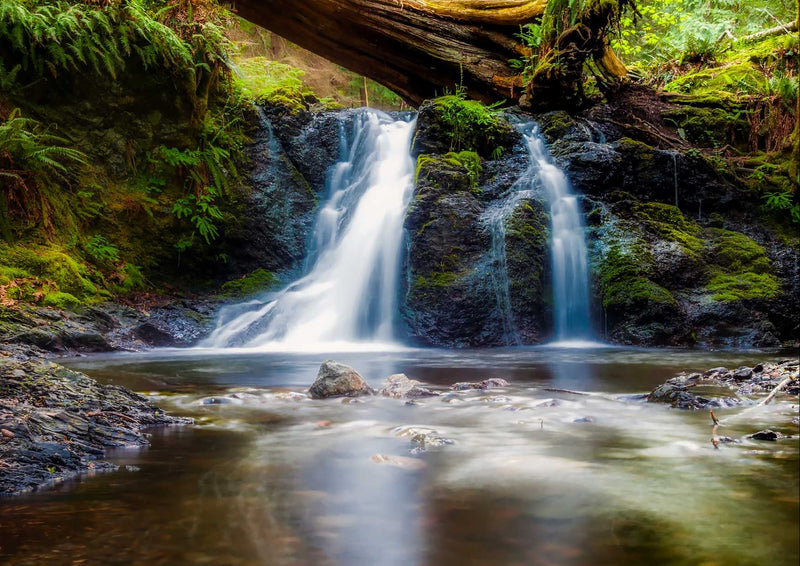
0, 0, 229, 117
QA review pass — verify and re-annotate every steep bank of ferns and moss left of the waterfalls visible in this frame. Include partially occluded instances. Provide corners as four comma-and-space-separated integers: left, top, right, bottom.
0, 0, 251, 305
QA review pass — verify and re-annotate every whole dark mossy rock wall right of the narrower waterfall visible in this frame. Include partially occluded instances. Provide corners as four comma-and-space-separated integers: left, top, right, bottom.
539, 113, 800, 347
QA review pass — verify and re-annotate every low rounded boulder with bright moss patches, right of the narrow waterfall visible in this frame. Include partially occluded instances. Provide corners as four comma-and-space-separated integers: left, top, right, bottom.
590, 192, 797, 347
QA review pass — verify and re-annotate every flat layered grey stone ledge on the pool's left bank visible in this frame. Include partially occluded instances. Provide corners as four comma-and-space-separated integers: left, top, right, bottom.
0, 359, 192, 496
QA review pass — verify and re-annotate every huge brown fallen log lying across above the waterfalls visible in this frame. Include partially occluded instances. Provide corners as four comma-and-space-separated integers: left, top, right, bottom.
234, 0, 546, 105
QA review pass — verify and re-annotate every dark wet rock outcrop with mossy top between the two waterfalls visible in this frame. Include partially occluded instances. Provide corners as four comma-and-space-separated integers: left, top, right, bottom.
403, 103, 550, 347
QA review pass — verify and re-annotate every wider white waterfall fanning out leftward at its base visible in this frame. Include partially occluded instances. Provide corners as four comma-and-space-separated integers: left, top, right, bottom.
202, 110, 415, 350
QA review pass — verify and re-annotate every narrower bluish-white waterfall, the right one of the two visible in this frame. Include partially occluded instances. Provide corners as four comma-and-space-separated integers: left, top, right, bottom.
523, 124, 592, 342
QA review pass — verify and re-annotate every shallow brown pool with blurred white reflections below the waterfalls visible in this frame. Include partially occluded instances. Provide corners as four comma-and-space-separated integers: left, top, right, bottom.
0, 348, 800, 566
